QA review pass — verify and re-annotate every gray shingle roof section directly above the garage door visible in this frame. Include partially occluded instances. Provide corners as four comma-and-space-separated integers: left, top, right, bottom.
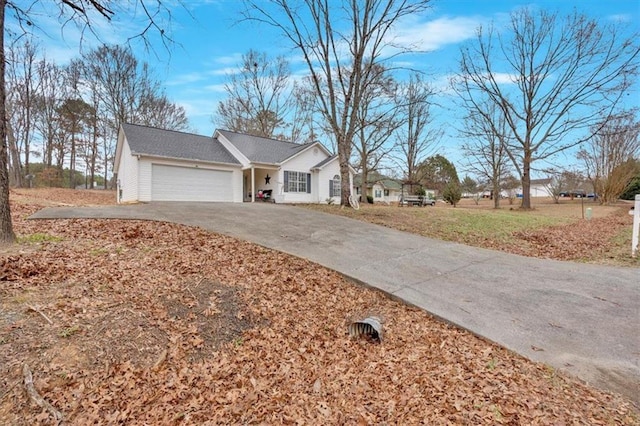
122, 124, 240, 164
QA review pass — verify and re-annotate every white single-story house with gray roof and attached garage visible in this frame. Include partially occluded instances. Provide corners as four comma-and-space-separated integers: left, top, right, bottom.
114, 124, 353, 203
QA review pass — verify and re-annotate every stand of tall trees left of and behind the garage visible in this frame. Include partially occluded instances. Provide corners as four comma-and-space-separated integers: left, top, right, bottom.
6, 38, 188, 188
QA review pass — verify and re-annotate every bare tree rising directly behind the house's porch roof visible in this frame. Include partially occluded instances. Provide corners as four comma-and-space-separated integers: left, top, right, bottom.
216, 50, 292, 138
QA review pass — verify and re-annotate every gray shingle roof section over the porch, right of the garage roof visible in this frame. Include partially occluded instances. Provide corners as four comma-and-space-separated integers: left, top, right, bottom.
218, 130, 313, 164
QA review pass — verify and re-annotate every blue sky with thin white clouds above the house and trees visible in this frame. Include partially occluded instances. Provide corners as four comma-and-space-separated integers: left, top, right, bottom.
15, 0, 640, 173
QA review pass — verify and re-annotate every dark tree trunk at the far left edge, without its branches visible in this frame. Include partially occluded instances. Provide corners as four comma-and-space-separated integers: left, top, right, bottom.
0, 0, 16, 244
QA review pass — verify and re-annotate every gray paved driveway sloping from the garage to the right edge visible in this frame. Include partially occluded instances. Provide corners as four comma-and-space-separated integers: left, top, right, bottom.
32, 203, 640, 406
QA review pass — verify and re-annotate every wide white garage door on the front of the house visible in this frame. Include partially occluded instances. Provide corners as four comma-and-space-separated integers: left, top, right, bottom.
151, 164, 233, 201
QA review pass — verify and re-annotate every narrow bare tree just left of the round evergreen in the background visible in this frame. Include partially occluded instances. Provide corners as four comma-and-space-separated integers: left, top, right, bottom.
395, 74, 443, 183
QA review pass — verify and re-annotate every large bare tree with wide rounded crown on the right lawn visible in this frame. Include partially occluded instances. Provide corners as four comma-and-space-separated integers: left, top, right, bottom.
457, 9, 640, 209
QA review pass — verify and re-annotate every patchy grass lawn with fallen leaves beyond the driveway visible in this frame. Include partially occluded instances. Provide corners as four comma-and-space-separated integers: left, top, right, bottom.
304, 199, 640, 266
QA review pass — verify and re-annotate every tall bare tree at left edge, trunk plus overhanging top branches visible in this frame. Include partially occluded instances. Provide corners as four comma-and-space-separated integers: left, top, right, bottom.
0, 0, 180, 243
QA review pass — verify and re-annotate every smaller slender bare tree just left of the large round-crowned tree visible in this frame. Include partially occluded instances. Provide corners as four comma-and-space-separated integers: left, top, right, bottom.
460, 103, 511, 209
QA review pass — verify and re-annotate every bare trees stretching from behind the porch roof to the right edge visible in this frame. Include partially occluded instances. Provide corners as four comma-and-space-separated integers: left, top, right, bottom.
236, 0, 640, 209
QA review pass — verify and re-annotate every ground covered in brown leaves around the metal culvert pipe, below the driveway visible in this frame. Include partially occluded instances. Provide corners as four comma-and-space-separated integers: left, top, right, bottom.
0, 192, 640, 425
